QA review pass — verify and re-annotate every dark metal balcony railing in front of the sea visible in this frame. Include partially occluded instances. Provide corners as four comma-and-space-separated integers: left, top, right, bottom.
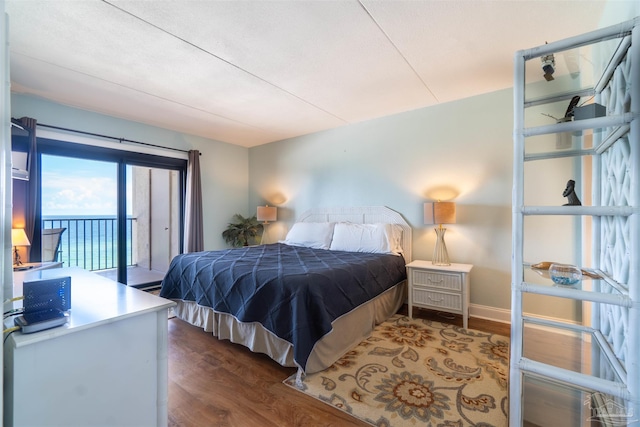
42, 217, 136, 271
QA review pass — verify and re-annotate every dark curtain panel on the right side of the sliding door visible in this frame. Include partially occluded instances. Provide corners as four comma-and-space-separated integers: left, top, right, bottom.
184, 150, 204, 253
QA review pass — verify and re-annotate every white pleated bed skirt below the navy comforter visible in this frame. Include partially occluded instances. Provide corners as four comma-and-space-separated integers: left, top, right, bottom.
174, 281, 406, 374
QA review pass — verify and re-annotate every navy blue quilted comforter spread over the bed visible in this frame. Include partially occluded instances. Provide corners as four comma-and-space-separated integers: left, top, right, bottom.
160, 243, 407, 370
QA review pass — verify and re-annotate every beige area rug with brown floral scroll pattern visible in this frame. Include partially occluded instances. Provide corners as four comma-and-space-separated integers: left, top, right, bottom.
284, 315, 509, 427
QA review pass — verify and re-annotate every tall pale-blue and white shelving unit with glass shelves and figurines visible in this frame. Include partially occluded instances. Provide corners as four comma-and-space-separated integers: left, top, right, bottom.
509, 17, 640, 426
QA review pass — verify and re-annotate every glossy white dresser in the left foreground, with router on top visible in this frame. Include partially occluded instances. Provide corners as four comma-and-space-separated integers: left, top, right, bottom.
4, 267, 175, 427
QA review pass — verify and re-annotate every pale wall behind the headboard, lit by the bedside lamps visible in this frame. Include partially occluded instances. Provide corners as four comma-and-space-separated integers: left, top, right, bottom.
249, 90, 516, 318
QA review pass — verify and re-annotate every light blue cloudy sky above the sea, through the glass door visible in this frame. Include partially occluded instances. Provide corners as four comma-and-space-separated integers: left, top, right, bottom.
42, 155, 131, 217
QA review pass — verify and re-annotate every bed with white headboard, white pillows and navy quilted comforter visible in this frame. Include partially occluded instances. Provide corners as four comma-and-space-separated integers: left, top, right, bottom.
160, 207, 411, 374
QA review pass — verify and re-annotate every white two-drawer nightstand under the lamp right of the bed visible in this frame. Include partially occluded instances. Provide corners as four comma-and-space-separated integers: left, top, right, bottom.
407, 260, 473, 329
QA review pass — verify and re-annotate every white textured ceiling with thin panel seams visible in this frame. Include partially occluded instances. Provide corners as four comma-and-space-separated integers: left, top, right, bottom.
6, 0, 606, 147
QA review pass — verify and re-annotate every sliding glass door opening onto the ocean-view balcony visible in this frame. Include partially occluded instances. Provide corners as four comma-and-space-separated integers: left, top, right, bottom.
39, 140, 186, 288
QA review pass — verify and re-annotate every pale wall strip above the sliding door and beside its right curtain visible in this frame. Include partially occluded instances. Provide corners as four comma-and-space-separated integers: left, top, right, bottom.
11, 94, 249, 250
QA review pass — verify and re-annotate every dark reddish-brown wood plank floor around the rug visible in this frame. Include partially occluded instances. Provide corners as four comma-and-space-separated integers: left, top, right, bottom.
169, 307, 509, 427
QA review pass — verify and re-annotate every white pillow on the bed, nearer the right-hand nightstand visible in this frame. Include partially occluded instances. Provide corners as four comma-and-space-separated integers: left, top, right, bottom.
330, 222, 402, 255
